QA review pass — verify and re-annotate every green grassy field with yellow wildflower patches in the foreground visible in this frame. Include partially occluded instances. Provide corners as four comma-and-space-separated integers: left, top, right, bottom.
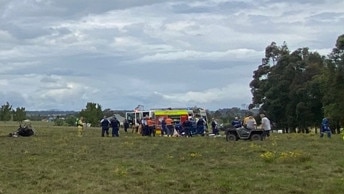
0, 123, 344, 194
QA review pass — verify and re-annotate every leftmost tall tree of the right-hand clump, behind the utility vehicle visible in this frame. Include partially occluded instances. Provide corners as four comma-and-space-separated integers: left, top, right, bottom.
249, 42, 290, 131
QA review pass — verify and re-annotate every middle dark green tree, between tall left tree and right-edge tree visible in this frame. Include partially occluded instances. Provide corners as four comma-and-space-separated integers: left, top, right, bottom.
287, 48, 324, 132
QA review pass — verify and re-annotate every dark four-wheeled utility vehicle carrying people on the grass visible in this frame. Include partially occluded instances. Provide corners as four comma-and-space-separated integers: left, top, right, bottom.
226, 127, 264, 141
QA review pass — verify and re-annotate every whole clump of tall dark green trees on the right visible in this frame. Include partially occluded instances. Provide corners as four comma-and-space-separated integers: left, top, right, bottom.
249, 34, 344, 133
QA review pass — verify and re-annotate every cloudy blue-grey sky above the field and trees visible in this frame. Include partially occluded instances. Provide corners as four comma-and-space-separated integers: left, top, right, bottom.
0, 0, 344, 111
